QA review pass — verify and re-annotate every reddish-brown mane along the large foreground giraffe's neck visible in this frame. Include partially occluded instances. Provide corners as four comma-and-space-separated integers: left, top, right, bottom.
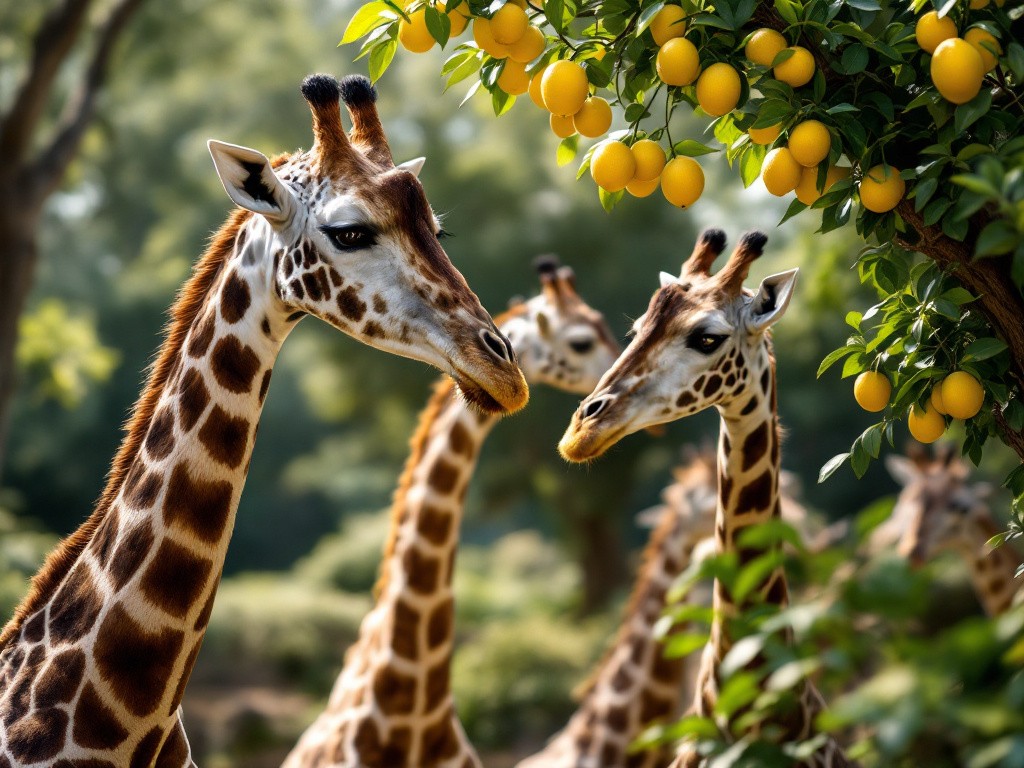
0, 196, 270, 650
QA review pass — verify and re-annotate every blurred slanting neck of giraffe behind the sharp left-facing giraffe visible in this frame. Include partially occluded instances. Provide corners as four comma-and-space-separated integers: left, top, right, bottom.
517, 506, 706, 768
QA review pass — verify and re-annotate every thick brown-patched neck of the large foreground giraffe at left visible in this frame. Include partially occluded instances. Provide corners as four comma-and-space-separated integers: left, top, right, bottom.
0, 217, 290, 765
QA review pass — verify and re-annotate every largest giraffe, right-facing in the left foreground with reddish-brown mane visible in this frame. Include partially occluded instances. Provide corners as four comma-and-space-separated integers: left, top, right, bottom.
0, 75, 527, 768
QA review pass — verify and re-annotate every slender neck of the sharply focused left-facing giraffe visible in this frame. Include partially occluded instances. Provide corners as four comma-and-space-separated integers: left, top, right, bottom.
711, 349, 787, 662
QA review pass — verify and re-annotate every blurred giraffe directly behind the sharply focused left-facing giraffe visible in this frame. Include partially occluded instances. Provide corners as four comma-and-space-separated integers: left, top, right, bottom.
516, 451, 718, 768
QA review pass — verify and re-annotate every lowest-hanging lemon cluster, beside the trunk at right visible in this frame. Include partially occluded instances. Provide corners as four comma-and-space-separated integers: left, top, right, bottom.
853, 371, 985, 442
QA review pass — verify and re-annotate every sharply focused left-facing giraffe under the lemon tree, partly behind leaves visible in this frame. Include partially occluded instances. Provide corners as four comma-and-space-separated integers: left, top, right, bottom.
559, 229, 849, 768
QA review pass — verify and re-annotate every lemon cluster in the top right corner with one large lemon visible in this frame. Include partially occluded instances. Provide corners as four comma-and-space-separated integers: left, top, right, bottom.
913, 9, 1002, 104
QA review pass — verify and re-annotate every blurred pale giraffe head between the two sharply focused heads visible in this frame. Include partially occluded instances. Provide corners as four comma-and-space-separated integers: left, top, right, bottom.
501, 256, 621, 394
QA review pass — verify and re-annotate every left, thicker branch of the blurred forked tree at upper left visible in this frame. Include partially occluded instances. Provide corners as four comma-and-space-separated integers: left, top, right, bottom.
0, 0, 92, 165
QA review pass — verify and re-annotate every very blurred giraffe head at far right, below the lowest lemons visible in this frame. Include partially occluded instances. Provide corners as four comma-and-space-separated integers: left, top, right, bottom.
870, 446, 999, 566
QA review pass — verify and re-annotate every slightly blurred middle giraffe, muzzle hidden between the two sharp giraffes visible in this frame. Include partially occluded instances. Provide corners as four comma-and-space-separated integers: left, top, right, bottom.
284, 260, 620, 768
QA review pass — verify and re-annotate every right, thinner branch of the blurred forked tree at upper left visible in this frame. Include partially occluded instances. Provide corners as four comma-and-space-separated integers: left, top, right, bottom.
33, 0, 142, 195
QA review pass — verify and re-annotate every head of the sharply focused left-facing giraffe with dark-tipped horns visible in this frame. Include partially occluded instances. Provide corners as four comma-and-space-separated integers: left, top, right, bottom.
558, 229, 797, 462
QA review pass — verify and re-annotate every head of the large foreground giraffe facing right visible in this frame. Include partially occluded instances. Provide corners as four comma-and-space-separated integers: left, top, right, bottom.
209, 75, 528, 412
